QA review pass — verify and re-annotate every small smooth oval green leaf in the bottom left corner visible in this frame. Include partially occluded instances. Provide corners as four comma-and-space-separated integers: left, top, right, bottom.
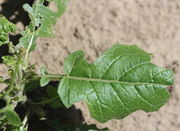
5, 109, 22, 127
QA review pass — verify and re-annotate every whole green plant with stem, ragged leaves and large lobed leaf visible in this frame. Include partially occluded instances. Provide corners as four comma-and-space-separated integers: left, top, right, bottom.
0, 0, 173, 131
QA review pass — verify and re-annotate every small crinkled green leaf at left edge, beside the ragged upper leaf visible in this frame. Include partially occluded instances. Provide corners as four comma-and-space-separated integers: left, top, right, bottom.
0, 15, 16, 46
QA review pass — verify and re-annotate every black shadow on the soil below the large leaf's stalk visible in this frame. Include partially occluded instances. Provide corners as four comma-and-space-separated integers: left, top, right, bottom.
16, 80, 84, 131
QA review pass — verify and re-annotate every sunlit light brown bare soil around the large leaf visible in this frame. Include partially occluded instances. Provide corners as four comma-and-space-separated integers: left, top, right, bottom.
0, 0, 180, 131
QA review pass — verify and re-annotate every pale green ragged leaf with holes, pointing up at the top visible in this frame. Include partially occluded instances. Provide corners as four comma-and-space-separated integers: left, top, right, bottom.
17, 0, 67, 50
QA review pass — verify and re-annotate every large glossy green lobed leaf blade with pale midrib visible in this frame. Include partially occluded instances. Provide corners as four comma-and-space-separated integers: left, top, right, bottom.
58, 44, 173, 122
